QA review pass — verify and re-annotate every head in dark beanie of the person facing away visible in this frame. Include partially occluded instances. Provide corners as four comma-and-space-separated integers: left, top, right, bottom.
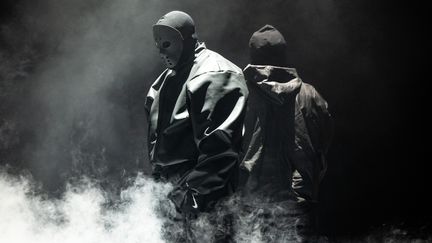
249, 25, 287, 67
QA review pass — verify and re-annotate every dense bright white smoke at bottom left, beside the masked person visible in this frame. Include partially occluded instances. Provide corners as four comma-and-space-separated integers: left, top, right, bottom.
0, 171, 170, 243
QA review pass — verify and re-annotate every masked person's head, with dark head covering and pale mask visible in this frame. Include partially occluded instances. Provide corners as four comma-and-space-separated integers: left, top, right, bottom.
153, 11, 197, 69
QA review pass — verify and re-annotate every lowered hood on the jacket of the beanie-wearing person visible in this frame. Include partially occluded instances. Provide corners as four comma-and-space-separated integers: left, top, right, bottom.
243, 64, 302, 105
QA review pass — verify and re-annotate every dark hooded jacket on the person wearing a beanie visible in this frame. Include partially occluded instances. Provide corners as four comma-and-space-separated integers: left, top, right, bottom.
241, 65, 333, 202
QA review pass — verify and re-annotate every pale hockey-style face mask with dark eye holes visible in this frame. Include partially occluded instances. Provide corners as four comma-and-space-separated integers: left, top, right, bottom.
153, 25, 183, 69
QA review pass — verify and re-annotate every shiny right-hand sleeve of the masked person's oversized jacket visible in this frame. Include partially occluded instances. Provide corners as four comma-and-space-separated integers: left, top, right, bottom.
171, 72, 248, 212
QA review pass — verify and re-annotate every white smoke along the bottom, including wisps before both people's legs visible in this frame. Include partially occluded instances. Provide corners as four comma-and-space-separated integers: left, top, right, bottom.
0, 168, 304, 243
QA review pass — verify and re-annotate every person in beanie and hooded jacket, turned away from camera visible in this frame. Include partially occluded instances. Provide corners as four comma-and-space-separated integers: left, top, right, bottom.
241, 25, 333, 242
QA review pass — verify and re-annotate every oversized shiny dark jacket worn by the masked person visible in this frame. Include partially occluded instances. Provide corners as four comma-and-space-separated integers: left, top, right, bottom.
146, 44, 248, 211
